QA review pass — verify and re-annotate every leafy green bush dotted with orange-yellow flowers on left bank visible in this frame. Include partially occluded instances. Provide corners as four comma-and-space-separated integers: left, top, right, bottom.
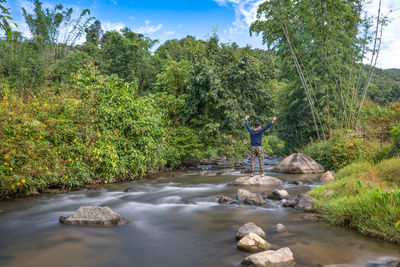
0, 65, 195, 199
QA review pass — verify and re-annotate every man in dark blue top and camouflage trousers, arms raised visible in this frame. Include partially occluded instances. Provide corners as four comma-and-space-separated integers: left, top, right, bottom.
245, 116, 276, 177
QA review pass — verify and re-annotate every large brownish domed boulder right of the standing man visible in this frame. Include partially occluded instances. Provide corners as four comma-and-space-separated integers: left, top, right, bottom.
271, 153, 325, 173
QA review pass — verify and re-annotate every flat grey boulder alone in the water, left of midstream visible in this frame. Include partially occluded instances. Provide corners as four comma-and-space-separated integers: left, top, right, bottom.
60, 206, 129, 226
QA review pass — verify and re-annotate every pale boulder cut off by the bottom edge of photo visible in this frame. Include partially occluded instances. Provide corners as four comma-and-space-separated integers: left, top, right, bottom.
242, 247, 294, 267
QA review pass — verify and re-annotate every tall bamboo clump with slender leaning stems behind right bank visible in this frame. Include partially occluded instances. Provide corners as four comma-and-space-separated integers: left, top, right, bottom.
250, 0, 383, 149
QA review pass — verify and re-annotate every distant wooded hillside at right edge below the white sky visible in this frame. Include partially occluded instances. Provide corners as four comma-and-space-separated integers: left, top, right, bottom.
368, 69, 400, 105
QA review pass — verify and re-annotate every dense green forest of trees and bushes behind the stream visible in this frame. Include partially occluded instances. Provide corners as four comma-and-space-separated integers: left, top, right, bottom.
0, 0, 400, 201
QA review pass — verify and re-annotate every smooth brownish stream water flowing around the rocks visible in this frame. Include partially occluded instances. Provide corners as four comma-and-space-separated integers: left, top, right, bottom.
0, 172, 400, 267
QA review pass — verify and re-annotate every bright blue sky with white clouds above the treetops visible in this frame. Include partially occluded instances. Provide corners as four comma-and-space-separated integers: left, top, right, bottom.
7, 0, 400, 68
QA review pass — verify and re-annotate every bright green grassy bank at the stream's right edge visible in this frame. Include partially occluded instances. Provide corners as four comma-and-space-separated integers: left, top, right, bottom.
308, 158, 400, 244
